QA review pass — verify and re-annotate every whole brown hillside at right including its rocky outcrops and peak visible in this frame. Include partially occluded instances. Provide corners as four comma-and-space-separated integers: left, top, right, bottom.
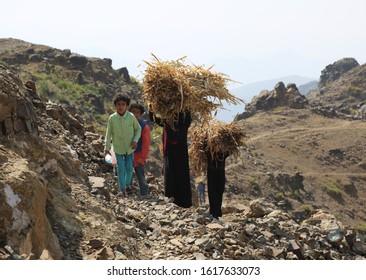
234, 59, 366, 232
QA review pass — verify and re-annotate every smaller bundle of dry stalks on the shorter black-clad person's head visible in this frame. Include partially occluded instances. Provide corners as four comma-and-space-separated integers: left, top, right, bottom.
188, 121, 245, 174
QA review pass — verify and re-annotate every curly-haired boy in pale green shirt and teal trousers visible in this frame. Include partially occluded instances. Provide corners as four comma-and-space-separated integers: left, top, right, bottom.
104, 94, 141, 196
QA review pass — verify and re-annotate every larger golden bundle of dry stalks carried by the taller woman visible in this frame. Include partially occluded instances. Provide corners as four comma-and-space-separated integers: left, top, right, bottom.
142, 56, 243, 123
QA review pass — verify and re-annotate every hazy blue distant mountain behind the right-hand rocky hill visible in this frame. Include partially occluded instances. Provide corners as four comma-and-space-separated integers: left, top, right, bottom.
216, 75, 318, 121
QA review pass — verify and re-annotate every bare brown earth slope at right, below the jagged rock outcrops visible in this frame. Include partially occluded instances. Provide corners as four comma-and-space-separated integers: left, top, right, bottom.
225, 108, 366, 229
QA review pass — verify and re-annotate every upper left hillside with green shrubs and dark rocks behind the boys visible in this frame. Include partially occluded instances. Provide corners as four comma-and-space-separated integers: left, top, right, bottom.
0, 39, 140, 133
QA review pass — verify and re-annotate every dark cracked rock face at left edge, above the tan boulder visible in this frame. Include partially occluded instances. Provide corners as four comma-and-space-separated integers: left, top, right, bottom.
0, 65, 37, 135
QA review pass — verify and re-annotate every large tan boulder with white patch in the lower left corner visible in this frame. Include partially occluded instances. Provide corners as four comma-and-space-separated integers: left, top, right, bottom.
0, 151, 63, 259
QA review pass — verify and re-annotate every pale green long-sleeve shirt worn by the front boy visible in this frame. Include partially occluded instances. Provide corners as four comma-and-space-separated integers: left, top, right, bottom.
104, 111, 141, 155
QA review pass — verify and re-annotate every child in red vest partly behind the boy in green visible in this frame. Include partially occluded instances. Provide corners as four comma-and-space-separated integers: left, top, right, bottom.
130, 103, 150, 198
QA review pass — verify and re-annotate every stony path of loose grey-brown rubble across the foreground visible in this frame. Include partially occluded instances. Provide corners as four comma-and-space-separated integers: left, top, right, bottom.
85, 182, 366, 260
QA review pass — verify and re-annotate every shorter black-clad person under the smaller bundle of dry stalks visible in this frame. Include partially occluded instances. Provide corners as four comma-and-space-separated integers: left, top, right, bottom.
206, 151, 229, 220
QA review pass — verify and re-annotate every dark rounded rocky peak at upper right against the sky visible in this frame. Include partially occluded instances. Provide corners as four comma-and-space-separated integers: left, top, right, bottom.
319, 58, 359, 89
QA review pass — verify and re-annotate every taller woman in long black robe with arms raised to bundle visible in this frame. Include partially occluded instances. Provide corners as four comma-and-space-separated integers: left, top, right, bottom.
149, 111, 192, 208
